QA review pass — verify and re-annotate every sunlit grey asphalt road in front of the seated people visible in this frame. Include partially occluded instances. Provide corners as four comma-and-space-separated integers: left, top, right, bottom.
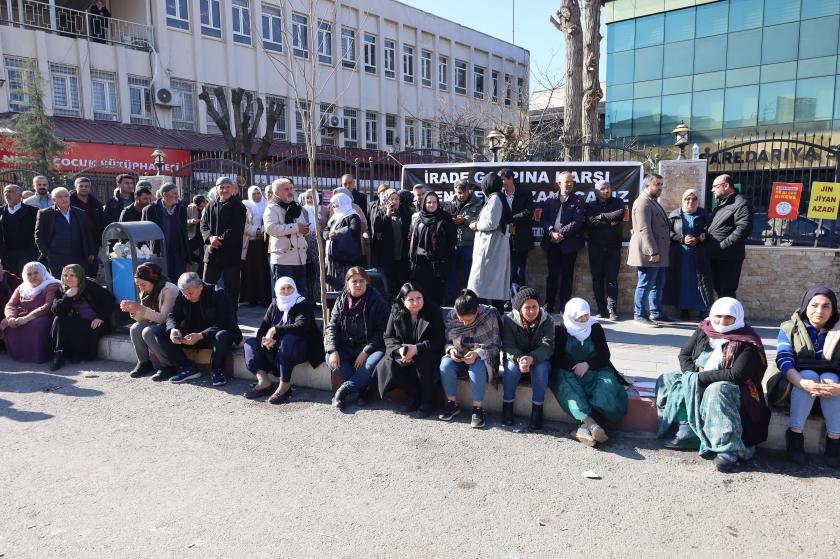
0, 356, 840, 558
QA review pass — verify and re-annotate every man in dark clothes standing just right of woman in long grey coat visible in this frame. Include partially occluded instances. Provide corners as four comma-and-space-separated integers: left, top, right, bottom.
499, 169, 534, 304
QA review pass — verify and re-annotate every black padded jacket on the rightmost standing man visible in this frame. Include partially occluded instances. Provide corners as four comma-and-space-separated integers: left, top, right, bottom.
707, 193, 753, 260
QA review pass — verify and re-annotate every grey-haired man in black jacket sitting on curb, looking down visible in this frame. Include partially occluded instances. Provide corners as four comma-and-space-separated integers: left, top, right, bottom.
157, 272, 242, 386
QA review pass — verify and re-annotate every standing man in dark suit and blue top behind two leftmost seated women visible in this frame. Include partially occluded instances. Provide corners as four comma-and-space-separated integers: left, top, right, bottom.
35, 186, 96, 278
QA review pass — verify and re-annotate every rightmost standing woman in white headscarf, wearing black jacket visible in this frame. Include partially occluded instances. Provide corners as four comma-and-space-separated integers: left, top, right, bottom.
323, 193, 362, 291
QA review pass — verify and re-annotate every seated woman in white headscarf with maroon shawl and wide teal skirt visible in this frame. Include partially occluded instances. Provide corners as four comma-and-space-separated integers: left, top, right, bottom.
656, 297, 770, 472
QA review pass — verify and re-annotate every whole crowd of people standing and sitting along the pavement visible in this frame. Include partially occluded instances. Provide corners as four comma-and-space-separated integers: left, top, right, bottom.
0, 169, 840, 471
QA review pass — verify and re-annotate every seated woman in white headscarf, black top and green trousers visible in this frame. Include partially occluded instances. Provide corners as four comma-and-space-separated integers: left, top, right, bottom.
549, 297, 627, 446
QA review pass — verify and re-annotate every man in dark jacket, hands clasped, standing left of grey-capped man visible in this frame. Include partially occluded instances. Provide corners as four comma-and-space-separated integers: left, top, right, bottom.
540, 171, 586, 313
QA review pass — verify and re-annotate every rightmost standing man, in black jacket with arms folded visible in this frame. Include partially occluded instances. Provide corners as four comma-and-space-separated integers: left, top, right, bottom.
706, 175, 753, 299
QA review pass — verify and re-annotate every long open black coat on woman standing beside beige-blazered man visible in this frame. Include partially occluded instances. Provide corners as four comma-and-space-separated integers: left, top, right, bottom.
662, 208, 715, 308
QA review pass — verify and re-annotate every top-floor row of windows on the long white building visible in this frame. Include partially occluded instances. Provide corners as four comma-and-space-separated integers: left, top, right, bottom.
166, 0, 526, 108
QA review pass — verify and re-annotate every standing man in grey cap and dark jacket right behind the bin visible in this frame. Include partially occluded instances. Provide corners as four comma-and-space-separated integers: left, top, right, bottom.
143, 182, 190, 278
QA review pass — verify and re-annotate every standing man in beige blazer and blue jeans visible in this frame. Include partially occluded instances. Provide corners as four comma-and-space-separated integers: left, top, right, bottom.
627, 174, 673, 328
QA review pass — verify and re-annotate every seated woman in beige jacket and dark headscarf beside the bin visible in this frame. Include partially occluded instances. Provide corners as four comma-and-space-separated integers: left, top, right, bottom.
120, 262, 178, 382
